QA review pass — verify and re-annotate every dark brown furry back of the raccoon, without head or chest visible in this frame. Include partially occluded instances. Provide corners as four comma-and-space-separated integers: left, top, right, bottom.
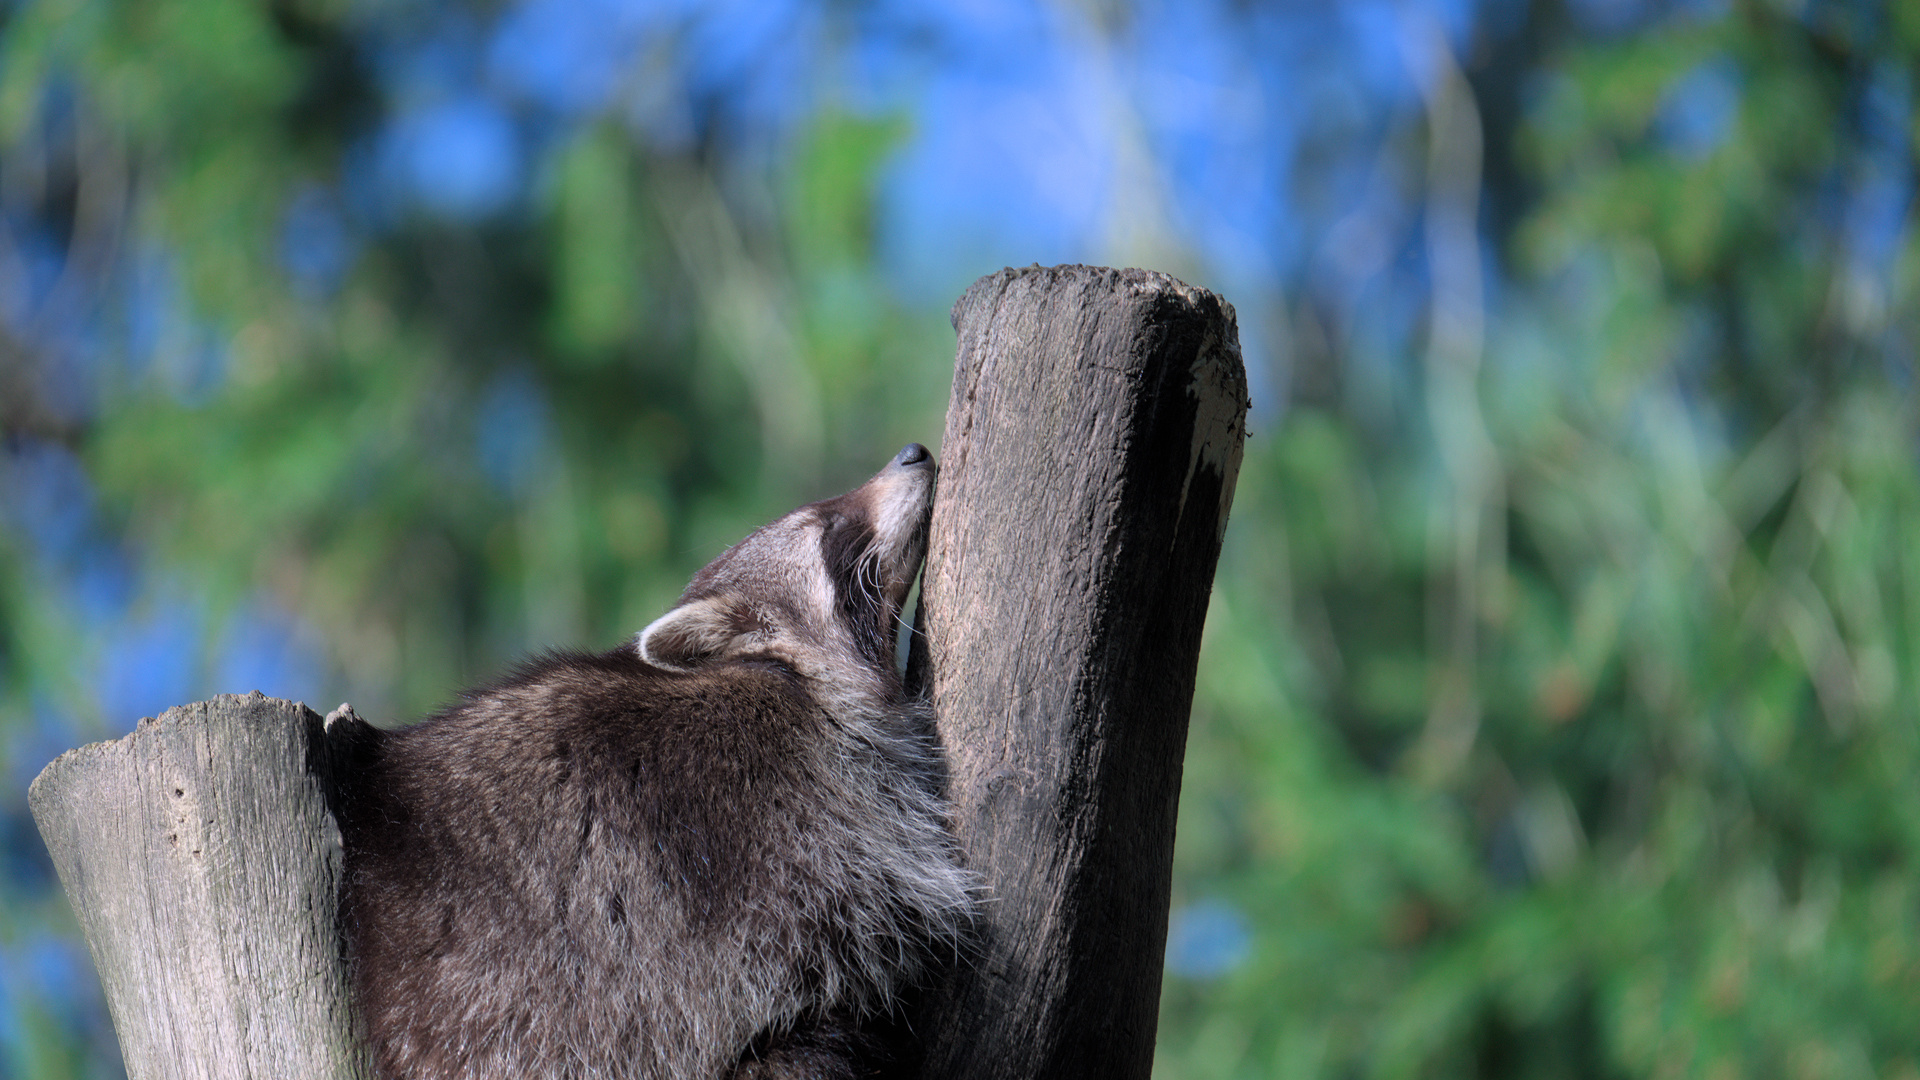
342, 651, 864, 1078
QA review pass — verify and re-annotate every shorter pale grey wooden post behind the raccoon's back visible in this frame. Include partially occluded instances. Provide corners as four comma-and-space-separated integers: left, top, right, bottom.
29, 694, 371, 1080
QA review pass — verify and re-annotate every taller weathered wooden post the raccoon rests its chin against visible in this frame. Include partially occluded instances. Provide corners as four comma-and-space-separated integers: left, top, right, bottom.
908, 267, 1248, 1080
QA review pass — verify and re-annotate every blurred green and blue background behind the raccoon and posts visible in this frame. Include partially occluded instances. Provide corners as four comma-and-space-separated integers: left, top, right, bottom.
0, 0, 1920, 1078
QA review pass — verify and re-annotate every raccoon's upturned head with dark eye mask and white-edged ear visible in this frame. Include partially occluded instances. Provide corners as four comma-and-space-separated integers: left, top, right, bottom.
637, 442, 935, 686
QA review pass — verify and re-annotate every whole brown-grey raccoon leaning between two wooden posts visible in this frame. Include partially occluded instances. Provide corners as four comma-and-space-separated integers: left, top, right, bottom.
342, 444, 973, 1080
